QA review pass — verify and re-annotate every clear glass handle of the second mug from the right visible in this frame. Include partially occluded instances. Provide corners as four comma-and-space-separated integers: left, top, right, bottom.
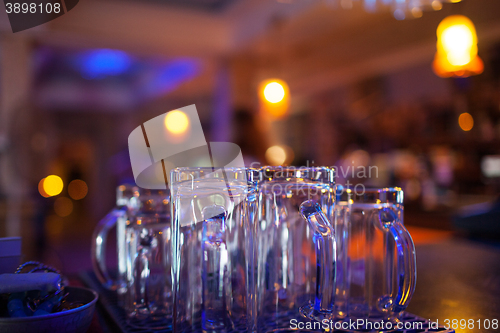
300, 200, 337, 321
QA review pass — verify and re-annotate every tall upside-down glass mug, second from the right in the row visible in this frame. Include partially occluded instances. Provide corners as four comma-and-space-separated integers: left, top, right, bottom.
249, 167, 336, 332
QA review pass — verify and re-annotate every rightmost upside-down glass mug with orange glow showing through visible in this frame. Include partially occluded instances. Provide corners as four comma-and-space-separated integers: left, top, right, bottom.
335, 188, 416, 321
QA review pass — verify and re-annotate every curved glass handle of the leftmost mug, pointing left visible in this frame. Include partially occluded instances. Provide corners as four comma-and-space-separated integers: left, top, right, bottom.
91, 209, 125, 290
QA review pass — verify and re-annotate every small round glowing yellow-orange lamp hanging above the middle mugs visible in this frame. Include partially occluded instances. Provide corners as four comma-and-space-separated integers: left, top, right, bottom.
259, 79, 290, 119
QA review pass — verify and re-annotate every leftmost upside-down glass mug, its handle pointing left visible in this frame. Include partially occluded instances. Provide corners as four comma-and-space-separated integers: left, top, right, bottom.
92, 185, 172, 327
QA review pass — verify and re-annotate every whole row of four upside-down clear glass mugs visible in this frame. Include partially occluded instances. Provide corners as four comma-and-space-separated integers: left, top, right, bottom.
93, 167, 416, 332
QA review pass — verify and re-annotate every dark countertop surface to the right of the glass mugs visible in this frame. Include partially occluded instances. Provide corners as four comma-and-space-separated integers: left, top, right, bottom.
407, 238, 500, 332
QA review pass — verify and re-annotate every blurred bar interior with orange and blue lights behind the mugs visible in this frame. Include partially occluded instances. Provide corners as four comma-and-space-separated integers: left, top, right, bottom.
0, 0, 500, 273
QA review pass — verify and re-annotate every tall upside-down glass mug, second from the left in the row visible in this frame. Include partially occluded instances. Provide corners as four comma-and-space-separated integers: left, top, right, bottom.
171, 168, 255, 332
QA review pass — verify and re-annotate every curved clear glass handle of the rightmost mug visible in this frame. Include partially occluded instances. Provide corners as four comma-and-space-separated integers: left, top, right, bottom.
378, 208, 417, 314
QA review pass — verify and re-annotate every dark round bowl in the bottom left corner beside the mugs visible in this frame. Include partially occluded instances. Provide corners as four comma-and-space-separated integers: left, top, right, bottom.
0, 287, 99, 333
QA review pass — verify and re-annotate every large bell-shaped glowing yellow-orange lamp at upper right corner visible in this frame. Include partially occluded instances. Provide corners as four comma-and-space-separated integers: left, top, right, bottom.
433, 15, 484, 77
